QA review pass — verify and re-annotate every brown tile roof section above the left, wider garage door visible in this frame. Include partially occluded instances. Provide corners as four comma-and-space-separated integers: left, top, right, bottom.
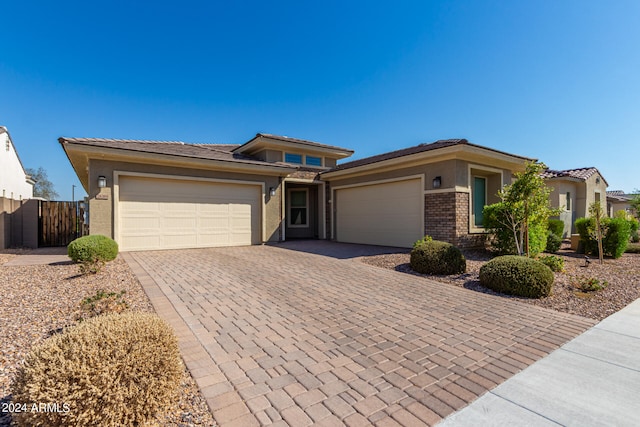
58, 137, 291, 169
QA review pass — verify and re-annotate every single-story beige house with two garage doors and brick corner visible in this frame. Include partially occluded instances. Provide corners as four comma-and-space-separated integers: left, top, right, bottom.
59, 133, 532, 251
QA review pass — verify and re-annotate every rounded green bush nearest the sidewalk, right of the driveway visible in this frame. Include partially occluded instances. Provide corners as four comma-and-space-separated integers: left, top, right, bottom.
480, 255, 554, 298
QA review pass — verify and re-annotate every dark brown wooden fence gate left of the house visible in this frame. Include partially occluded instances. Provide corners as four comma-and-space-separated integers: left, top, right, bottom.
38, 200, 88, 247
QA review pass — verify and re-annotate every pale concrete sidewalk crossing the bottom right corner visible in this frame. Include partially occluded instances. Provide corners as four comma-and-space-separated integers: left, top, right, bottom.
438, 299, 640, 427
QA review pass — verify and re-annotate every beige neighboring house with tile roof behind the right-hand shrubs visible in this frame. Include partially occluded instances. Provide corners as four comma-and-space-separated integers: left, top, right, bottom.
542, 167, 609, 237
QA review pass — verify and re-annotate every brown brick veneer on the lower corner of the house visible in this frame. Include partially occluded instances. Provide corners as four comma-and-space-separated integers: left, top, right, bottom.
424, 192, 484, 248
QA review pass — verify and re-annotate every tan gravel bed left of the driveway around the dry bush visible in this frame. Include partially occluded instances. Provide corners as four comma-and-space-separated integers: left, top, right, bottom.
0, 251, 215, 427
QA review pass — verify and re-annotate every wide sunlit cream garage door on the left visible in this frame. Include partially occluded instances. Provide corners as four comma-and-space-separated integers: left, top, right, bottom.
116, 176, 262, 251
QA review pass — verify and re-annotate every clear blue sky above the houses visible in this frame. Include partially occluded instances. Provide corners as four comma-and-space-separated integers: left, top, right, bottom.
0, 0, 640, 200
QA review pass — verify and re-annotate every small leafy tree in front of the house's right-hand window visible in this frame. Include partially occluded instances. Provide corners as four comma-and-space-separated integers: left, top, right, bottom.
487, 162, 559, 256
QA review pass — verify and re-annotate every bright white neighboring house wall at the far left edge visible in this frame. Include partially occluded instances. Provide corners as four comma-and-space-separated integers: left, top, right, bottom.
0, 126, 35, 200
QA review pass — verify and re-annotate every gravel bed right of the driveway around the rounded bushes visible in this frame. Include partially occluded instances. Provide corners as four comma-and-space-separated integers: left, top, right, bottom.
360, 243, 640, 320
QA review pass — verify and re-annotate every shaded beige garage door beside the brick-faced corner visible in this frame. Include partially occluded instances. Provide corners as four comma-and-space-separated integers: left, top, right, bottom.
336, 179, 424, 247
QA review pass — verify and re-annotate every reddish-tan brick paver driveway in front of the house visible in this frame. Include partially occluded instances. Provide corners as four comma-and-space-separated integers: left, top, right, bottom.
125, 242, 595, 426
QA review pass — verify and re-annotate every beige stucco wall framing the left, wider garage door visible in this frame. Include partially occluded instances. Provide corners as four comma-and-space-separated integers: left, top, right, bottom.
88, 160, 282, 242
